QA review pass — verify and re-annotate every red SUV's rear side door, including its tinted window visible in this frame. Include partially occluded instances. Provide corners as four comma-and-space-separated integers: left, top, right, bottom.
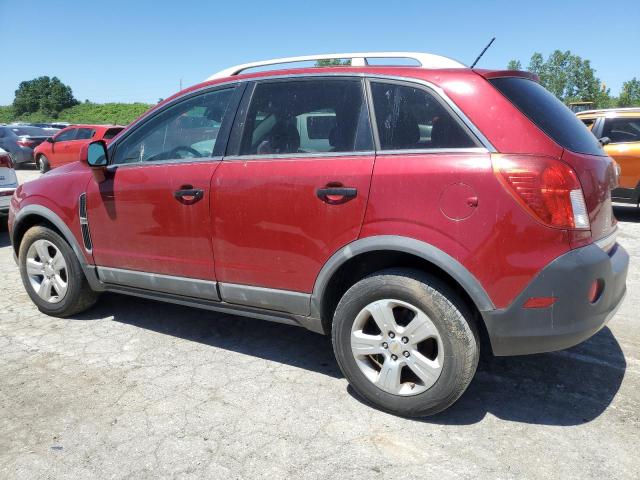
211, 78, 374, 314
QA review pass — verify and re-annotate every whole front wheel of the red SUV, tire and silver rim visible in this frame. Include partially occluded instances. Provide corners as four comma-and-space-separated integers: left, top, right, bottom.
19, 226, 98, 317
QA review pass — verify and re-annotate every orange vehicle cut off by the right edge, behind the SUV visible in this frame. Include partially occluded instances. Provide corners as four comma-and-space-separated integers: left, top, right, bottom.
576, 108, 640, 205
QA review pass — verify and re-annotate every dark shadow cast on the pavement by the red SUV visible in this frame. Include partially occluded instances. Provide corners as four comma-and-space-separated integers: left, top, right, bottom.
76, 294, 626, 425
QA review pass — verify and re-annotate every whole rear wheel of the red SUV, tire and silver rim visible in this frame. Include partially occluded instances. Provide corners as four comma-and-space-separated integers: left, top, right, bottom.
332, 269, 480, 417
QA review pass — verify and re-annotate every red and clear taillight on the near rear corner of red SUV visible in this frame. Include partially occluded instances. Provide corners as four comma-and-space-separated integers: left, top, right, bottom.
491, 155, 589, 229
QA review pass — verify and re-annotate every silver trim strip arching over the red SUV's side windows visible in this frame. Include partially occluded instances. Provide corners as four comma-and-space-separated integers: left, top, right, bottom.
120, 72, 498, 158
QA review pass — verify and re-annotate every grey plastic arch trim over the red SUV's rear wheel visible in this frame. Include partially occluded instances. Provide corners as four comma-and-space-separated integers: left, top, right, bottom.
311, 235, 496, 318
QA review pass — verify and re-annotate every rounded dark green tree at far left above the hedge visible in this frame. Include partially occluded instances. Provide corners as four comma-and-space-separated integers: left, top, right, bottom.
13, 76, 78, 118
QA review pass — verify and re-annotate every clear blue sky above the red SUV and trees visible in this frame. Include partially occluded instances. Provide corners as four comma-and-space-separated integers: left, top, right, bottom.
0, 0, 640, 105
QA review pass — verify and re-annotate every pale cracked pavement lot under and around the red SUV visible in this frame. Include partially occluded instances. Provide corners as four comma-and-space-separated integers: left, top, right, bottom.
0, 167, 640, 479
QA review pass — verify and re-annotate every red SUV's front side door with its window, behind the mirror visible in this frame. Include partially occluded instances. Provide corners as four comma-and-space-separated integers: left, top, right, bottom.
87, 86, 239, 290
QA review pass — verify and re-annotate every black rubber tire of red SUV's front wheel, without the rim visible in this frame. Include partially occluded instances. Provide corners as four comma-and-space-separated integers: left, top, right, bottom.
18, 225, 99, 318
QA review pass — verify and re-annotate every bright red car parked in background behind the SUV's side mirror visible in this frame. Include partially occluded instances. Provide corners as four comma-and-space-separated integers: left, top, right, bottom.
34, 125, 124, 173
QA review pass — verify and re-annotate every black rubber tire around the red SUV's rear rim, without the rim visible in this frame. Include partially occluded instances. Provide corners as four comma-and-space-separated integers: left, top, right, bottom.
332, 269, 480, 417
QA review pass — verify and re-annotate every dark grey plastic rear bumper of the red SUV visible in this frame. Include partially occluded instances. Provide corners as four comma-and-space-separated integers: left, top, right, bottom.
483, 240, 629, 355
